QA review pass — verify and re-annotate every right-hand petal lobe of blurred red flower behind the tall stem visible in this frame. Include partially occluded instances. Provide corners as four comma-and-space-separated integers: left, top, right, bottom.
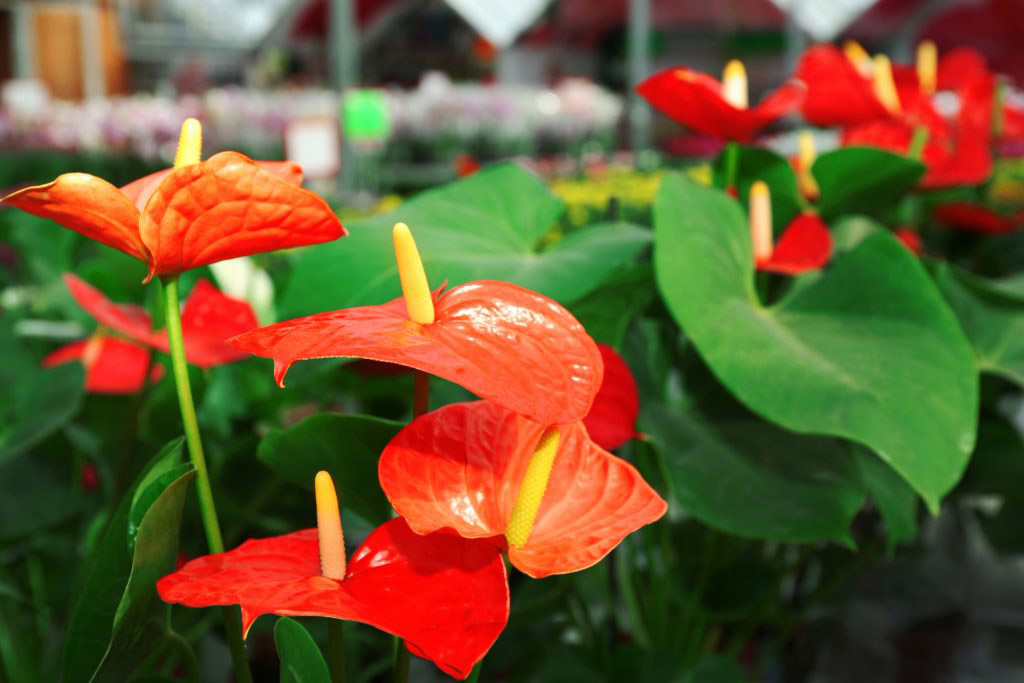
152, 280, 259, 368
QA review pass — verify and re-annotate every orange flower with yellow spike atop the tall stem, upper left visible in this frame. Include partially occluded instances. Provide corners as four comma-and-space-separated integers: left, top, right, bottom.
0, 119, 346, 281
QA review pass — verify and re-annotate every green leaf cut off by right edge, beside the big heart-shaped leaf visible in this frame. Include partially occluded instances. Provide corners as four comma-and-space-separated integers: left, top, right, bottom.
935, 263, 1024, 386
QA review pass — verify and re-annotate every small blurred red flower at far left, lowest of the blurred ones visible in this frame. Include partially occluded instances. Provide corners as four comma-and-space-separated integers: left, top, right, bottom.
43, 334, 164, 394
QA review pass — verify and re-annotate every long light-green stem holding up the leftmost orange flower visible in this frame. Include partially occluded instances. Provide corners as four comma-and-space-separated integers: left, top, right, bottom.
164, 276, 253, 683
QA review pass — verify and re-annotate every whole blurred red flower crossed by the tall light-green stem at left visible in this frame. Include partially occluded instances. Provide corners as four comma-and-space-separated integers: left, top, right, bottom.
65, 273, 259, 368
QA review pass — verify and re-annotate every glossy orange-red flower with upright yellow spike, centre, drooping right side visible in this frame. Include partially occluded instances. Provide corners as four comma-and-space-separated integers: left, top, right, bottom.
228, 223, 602, 424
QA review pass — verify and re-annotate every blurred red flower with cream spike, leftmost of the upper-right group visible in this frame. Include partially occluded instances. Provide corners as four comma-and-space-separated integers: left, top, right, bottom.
637, 59, 804, 142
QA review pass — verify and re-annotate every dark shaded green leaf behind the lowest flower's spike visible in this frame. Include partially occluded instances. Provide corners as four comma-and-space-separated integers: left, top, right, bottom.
256, 414, 404, 524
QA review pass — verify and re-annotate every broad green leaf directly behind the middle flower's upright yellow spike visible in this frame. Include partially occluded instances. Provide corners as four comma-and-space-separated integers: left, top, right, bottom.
281, 164, 650, 317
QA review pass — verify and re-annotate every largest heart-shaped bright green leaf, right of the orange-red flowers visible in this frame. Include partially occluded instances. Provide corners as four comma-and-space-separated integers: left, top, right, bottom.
654, 175, 978, 510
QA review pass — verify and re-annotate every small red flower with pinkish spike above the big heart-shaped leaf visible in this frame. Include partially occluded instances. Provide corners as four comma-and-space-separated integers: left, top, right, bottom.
750, 180, 831, 275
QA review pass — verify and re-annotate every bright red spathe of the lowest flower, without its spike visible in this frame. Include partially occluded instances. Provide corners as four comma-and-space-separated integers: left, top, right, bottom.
157, 519, 509, 679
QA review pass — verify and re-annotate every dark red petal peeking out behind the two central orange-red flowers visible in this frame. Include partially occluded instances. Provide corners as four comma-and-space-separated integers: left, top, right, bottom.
583, 344, 640, 451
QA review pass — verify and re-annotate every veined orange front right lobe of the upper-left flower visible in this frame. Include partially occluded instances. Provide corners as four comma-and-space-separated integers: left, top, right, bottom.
139, 152, 347, 278
